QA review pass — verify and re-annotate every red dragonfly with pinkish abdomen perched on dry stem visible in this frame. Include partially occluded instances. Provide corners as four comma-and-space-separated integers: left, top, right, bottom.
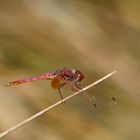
6, 67, 96, 107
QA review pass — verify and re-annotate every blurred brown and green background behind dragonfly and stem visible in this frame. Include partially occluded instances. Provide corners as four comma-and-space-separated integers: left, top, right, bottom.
0, 0, 140, 140
